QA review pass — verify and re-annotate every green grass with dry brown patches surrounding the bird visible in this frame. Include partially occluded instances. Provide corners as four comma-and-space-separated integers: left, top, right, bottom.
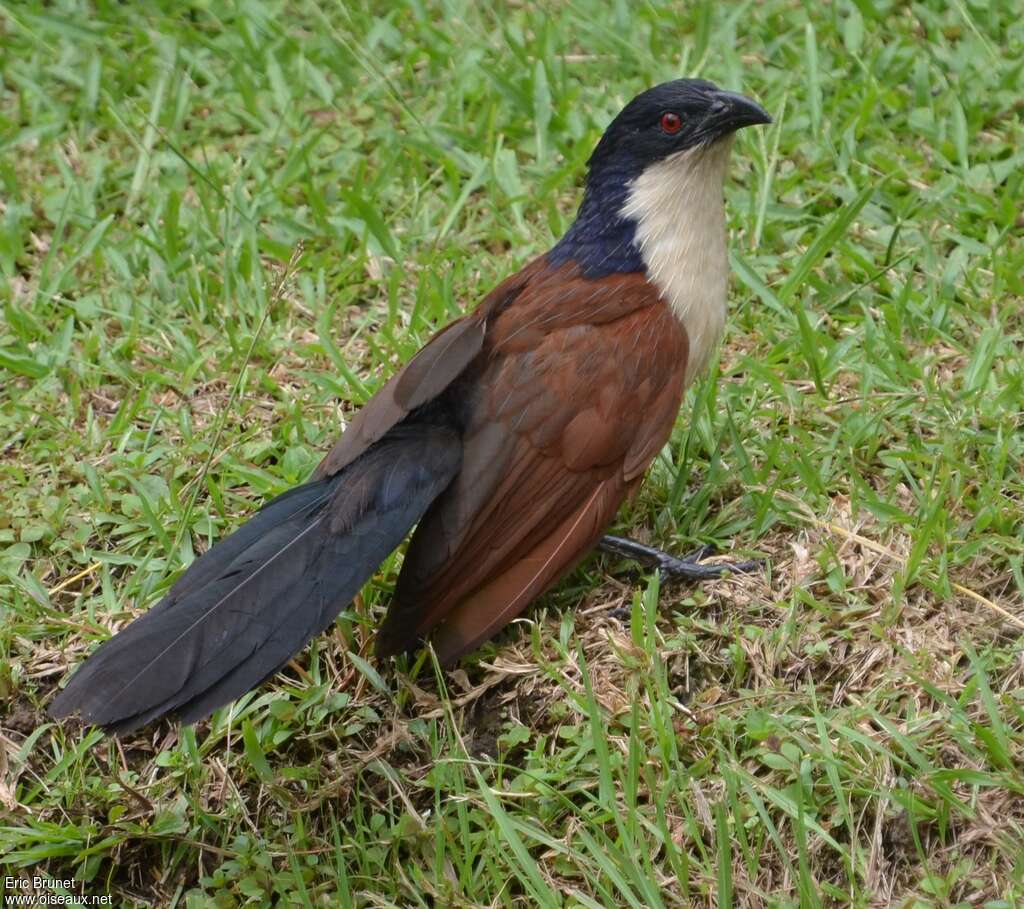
0, 0, 1024, 909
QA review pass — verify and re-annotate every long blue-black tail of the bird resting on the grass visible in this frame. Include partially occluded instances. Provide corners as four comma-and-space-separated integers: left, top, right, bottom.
49, 424, 462, 733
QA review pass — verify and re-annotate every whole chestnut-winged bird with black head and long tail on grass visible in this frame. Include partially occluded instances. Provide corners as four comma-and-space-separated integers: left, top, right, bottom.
49, 79, 771, 734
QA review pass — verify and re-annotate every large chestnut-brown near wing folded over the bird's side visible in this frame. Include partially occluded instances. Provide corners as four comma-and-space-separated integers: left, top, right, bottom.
378, 267, 687, 660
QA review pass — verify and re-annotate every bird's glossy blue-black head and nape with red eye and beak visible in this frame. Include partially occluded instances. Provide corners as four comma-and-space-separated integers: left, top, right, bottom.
549, 79, 771, 276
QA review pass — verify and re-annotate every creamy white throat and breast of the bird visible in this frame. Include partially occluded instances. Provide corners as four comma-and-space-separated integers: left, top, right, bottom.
622, 136, 732, 385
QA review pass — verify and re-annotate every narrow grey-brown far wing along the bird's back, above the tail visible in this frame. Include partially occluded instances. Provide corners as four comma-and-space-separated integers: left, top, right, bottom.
313, 259, 542, 479
